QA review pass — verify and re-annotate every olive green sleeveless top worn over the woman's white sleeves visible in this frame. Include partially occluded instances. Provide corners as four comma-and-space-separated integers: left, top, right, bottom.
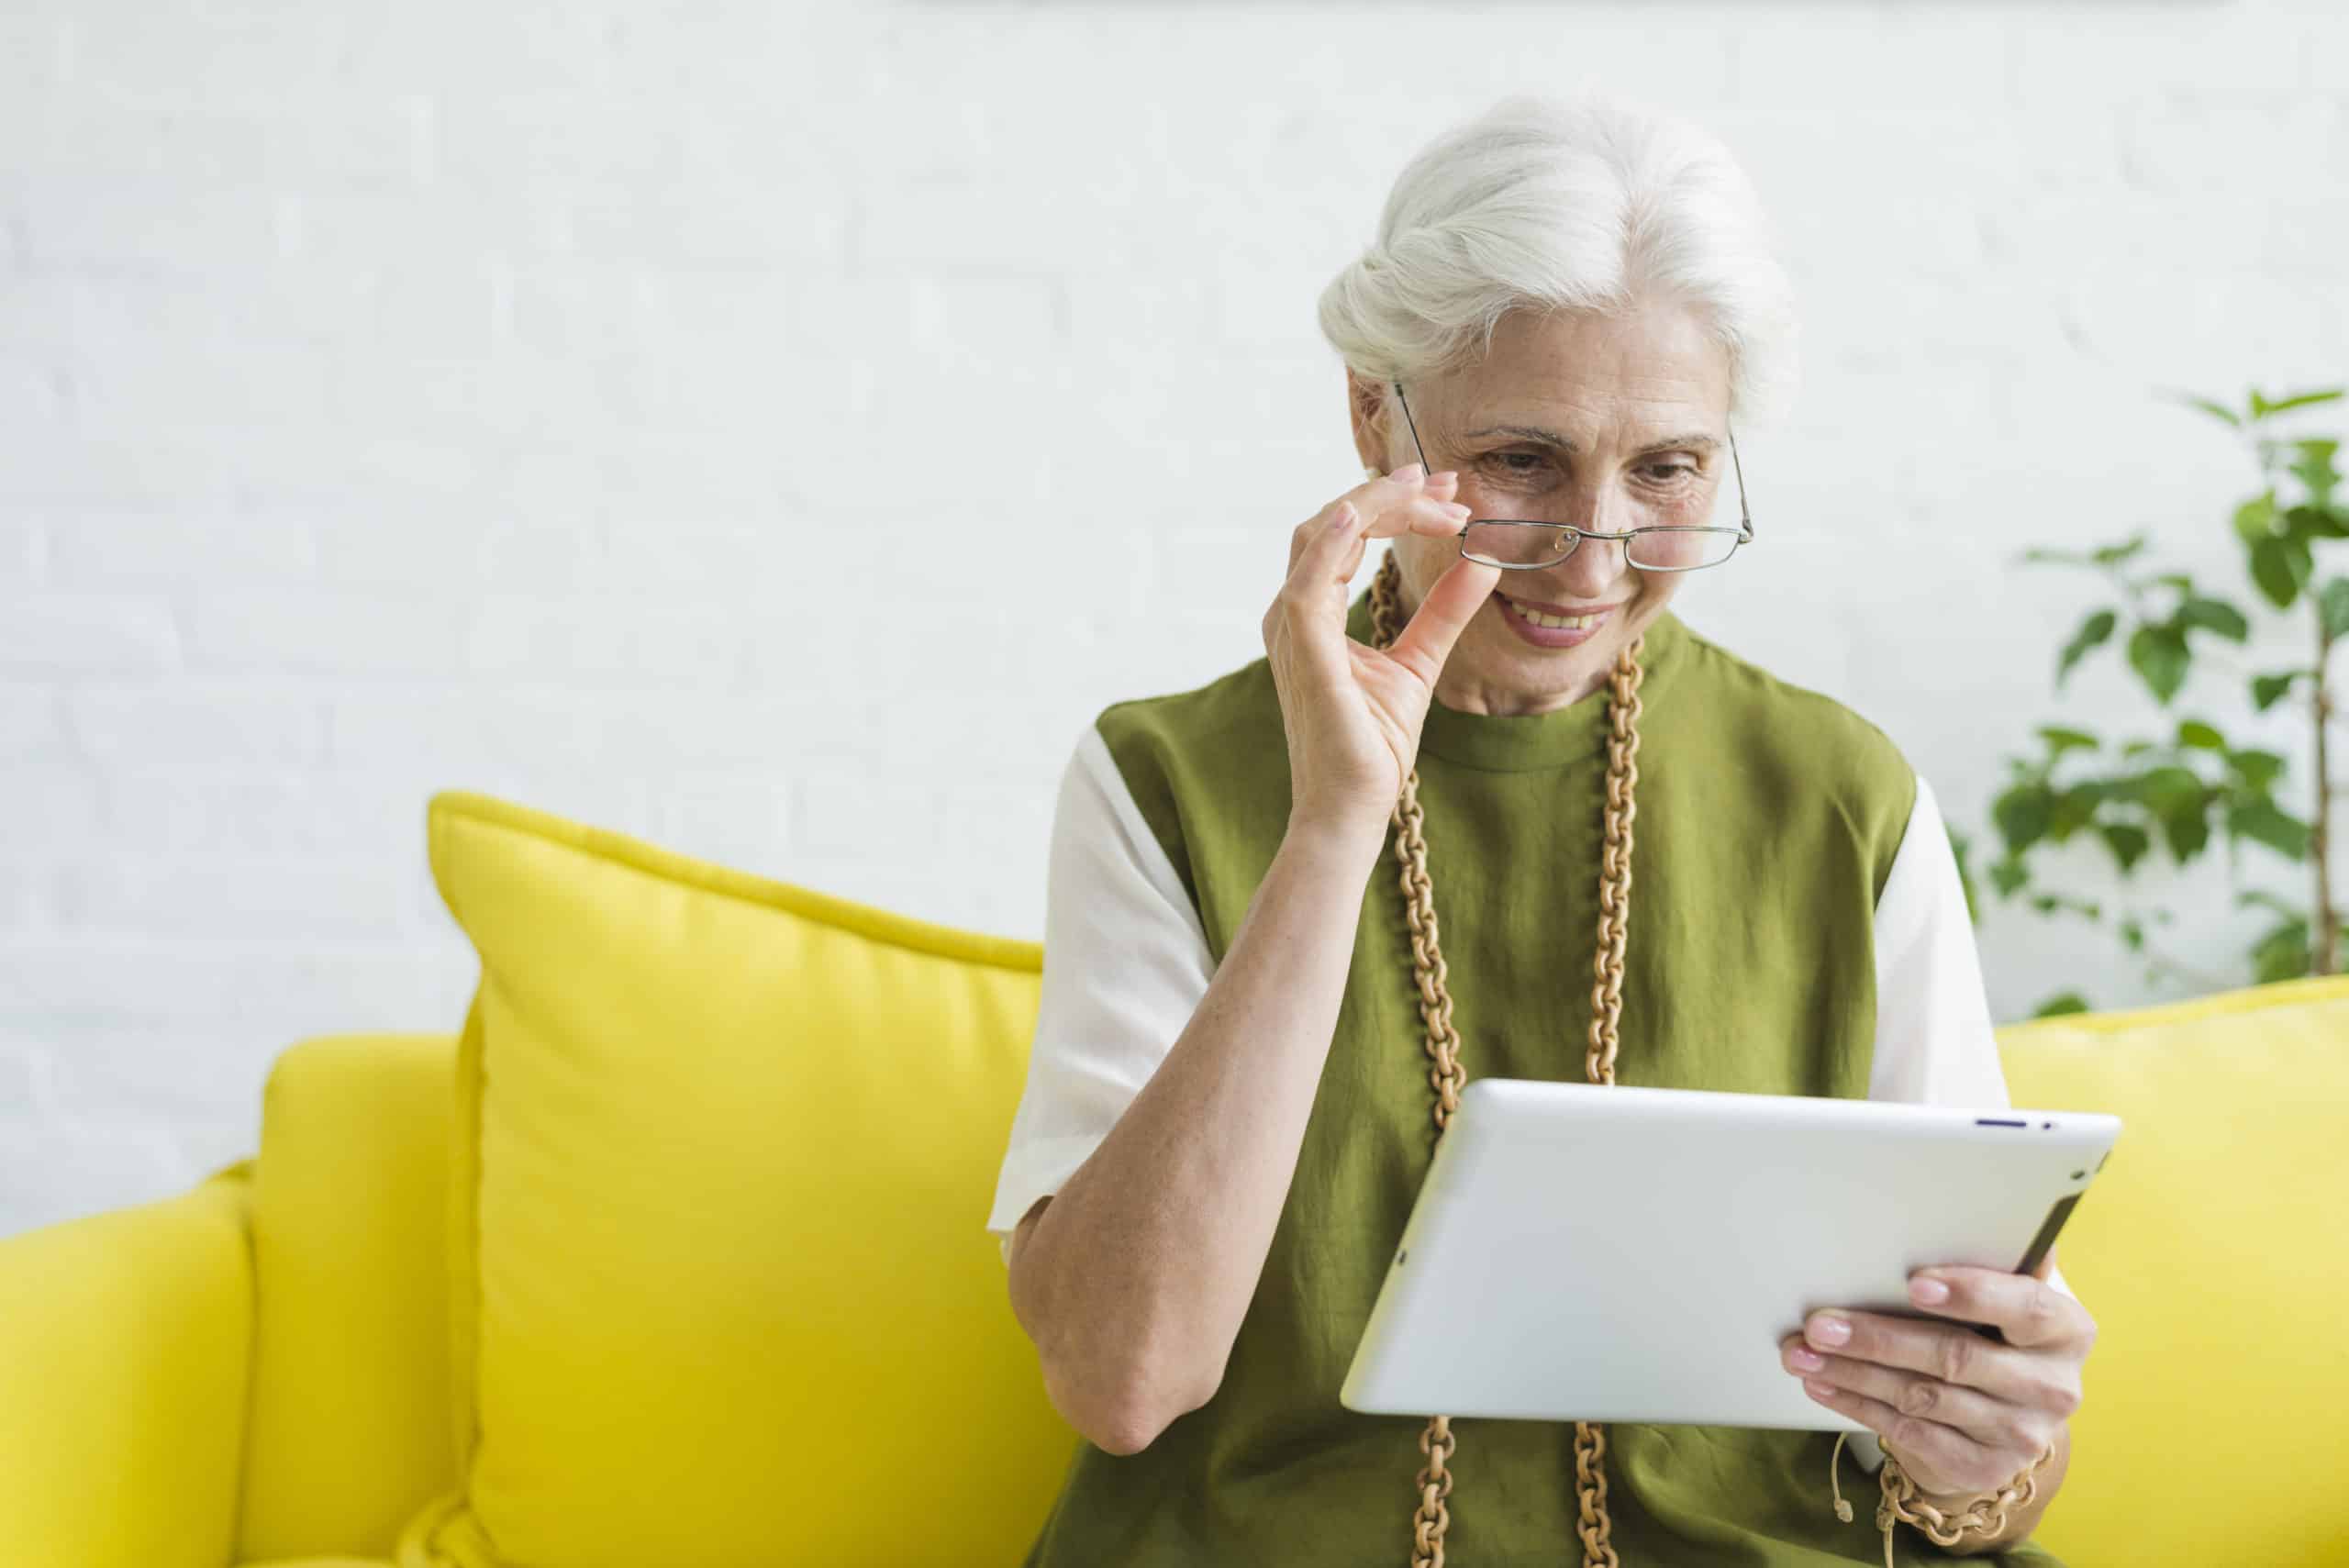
1029, 592, 2053, 1568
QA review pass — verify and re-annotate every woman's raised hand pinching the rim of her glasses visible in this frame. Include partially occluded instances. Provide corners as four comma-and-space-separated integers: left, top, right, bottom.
1264, 462, 1501, 836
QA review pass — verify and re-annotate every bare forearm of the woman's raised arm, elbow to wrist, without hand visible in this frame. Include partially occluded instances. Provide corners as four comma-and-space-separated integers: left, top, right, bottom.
1010, 819, 1384, 1453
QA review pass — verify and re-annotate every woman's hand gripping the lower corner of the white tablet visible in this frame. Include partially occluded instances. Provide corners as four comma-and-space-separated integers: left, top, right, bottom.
1778, 1262, 2096, 1496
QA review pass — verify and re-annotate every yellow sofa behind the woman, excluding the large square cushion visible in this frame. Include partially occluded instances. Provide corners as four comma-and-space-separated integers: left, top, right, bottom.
0, 948, 2349, 1568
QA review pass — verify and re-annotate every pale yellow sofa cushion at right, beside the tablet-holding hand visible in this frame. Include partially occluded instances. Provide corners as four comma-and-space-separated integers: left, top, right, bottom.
1999, 979, 2349, 1568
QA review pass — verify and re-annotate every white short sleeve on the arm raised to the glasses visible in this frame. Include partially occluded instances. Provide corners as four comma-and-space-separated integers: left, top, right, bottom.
986, 728, 1215, 1256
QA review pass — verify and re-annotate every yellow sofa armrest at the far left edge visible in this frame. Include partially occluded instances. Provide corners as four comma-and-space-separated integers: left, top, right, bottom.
0, 1160, 253, 1568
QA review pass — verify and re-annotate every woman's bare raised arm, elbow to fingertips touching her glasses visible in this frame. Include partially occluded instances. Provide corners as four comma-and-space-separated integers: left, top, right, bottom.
1006, 462, 1501, 1453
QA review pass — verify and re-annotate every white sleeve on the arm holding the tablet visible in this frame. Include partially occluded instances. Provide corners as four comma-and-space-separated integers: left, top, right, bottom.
1851, 774, 2076, 1470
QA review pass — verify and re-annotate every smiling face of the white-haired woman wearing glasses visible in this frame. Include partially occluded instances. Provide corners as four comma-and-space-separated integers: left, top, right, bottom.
1348, 306, 1736, 714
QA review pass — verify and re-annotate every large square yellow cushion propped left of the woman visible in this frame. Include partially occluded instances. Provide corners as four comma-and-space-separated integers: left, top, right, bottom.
399, 794, 1074, 1568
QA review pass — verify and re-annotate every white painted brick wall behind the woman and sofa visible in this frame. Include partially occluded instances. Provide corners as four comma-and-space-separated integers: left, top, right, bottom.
0, 0, 2349, 1232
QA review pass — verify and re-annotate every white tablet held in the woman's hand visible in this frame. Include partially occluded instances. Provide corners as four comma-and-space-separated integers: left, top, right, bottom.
1339, 1077, 2121, 1432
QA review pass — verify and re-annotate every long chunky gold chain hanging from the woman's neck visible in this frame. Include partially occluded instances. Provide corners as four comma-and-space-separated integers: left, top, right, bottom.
1369, 551, 1647, 1568
